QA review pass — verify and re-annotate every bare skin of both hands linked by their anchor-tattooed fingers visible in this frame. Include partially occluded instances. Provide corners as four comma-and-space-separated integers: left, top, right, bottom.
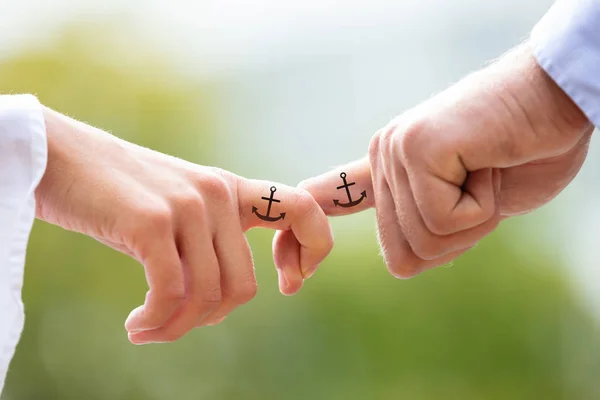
36, 40, 593, 344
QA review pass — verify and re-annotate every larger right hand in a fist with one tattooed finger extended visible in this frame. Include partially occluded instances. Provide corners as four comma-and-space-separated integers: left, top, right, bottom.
300, 45, 593, 278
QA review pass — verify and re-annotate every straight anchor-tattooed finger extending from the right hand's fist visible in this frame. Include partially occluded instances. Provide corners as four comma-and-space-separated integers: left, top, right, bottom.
298, 157, 375, 216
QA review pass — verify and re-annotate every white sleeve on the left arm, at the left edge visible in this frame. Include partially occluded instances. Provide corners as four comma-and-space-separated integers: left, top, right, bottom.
0, 95, 47, 392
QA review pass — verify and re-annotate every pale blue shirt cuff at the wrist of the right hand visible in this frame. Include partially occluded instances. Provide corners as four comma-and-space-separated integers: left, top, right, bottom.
531, 0, 600, 127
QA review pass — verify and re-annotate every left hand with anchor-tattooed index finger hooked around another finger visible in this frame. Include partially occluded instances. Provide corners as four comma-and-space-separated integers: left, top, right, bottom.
36, 109, 333, 344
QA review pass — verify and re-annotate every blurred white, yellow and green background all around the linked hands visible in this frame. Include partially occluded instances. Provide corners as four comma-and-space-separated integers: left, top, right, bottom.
0, 0, 600, 400
